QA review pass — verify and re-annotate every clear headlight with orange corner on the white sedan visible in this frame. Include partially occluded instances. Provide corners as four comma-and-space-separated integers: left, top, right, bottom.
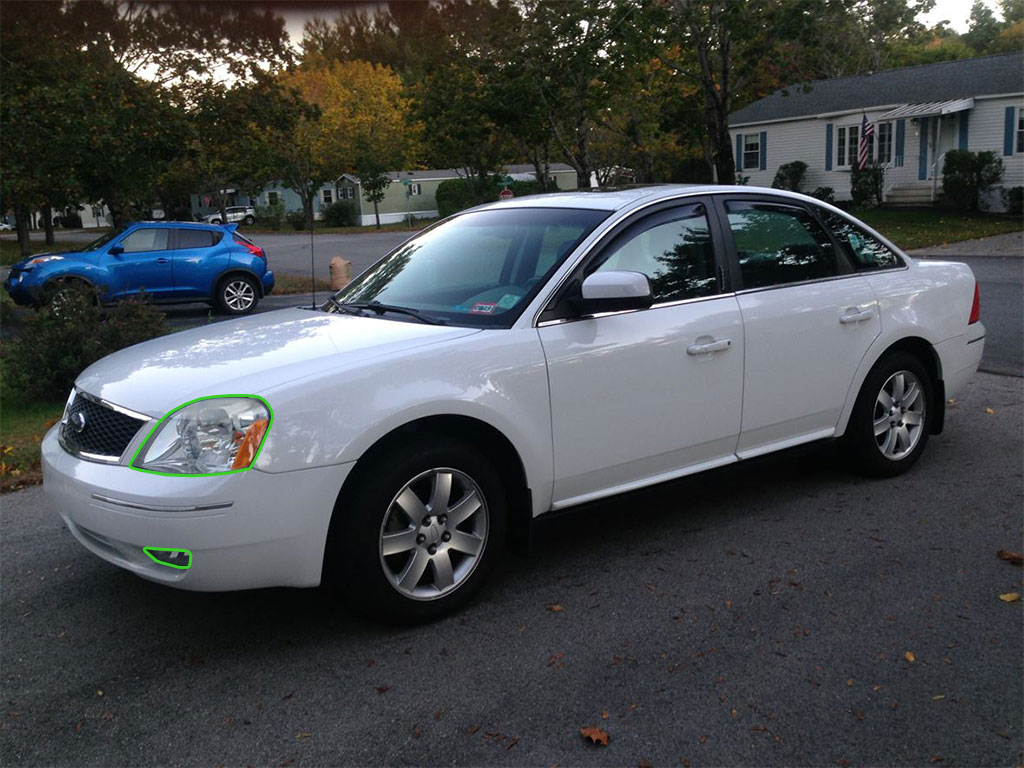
131, 394, 273, 475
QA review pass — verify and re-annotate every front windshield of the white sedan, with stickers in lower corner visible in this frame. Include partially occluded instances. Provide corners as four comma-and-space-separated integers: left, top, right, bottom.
325, 208, 608, 328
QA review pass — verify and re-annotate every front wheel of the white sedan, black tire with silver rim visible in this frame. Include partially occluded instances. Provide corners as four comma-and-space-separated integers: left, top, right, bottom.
327, 433, 506, 624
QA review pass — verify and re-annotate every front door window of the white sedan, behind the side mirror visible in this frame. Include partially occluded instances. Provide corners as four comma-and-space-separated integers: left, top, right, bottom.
597, 205, 718, 303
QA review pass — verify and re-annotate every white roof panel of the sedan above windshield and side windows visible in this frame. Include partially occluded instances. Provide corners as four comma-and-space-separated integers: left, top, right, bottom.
473, 184, 821, 218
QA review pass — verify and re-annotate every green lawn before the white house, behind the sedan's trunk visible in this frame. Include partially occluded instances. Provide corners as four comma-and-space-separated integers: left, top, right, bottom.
852, 208, 1024, 251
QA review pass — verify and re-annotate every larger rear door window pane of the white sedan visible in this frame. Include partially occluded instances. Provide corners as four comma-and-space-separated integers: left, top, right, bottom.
726, 201, 839, 289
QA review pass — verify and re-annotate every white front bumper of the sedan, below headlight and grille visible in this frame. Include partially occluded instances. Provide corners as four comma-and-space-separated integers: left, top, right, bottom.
42, 425, 352, 591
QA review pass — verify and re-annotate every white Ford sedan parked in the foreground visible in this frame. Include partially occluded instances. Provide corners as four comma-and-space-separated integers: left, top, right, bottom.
43, 186, 985, 621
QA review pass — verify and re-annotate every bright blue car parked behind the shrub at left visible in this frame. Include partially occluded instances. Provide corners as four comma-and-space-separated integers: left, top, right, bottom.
3, 221, 273, 314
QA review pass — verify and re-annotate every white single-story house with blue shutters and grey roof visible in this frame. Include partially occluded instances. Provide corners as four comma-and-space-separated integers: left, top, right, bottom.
729, 52, 1024, 207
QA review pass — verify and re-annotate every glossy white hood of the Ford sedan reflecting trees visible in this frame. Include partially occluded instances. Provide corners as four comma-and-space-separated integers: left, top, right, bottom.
75, 308, 479, 418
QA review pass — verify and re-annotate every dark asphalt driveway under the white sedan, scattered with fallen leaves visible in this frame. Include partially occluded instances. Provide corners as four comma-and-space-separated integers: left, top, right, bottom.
0, 375, 1024, 766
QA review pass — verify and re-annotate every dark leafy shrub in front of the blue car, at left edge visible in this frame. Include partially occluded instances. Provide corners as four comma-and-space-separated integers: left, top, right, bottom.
4, 291, 169, 400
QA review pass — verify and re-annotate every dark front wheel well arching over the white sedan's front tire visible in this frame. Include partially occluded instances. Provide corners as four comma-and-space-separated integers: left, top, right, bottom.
324, 414, 532, 583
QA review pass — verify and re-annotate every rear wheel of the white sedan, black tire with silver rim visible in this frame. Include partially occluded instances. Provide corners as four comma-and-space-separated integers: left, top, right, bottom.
846, 352, 936, 477
